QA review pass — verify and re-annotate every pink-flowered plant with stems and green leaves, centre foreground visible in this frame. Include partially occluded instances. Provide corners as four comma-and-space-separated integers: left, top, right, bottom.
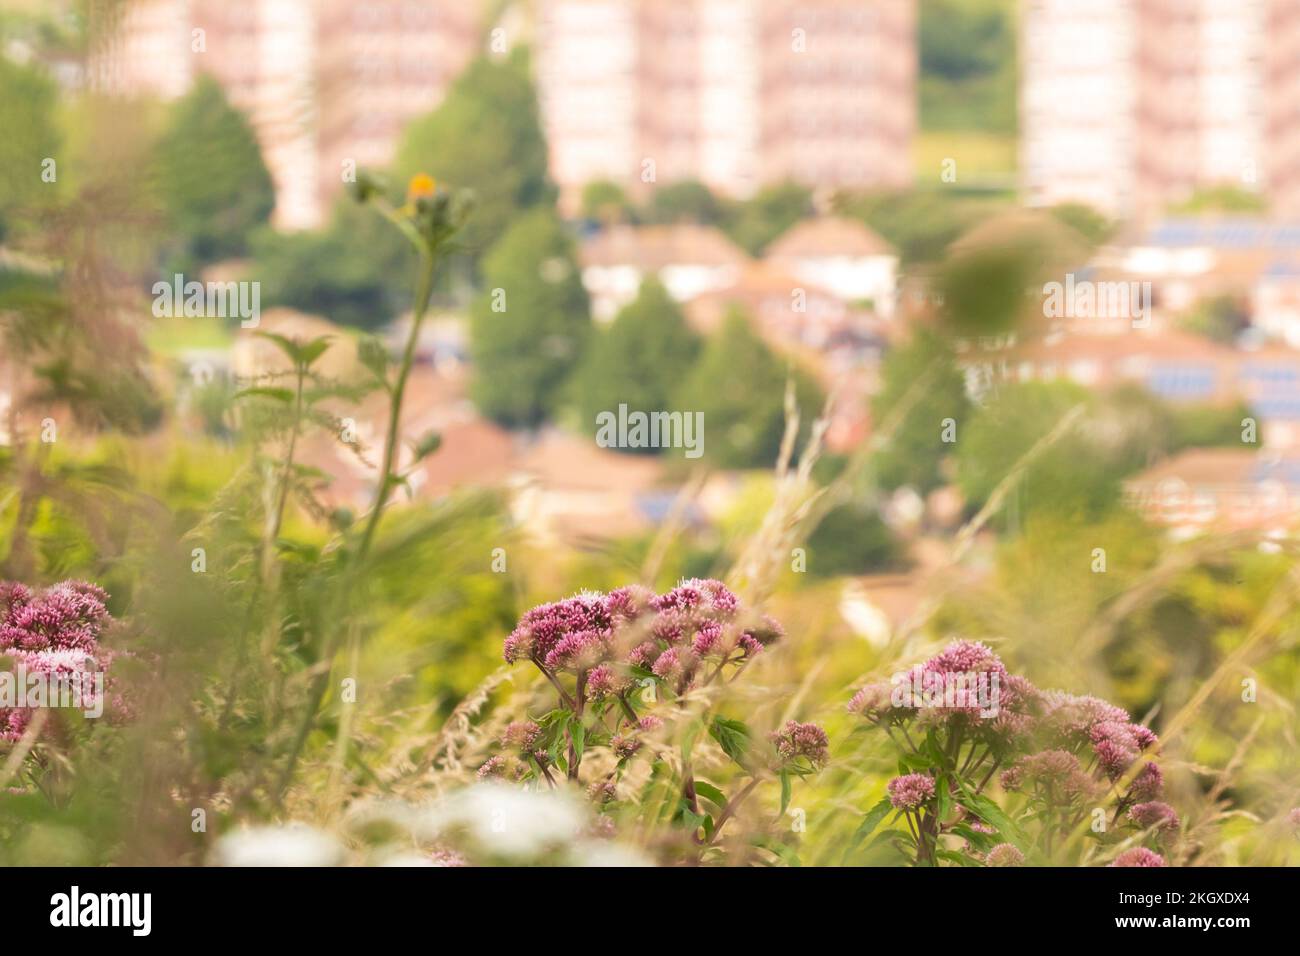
478, 579, 828, 857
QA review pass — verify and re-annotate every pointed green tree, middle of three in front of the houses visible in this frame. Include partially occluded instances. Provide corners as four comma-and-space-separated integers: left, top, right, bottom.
576, 278, 699, 444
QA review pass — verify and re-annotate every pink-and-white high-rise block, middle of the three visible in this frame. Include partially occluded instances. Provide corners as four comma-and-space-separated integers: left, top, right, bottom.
537, 0, 917, 210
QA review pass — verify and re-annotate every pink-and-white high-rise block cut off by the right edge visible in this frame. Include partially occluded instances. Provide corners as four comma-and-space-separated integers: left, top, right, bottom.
1021, 0, 1300, 217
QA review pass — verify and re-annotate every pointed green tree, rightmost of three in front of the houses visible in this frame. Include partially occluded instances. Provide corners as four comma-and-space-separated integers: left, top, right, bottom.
675, 311, 823, 468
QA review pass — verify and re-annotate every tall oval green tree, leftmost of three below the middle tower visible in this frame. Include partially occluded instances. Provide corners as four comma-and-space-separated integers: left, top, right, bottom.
469, 208, 592, 427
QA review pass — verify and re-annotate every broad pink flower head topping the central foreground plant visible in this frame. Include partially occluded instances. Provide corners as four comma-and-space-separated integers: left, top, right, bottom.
503, 579, 781, 700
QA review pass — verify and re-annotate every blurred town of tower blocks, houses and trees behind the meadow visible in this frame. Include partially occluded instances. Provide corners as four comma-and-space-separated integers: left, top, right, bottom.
0, 0, 1300, 634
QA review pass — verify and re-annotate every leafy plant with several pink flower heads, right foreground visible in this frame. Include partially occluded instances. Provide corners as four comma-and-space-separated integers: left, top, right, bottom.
849, 641, 1179, 866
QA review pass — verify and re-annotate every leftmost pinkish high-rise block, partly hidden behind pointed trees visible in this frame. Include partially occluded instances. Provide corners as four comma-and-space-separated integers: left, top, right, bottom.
92, 0, 481, 229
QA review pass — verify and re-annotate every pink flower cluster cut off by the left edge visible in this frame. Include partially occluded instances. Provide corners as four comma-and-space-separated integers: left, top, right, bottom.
0, 581, 112, 740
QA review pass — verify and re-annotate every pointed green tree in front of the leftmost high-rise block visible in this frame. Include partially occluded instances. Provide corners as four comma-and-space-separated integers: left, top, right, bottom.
156, 75, 276, 272
